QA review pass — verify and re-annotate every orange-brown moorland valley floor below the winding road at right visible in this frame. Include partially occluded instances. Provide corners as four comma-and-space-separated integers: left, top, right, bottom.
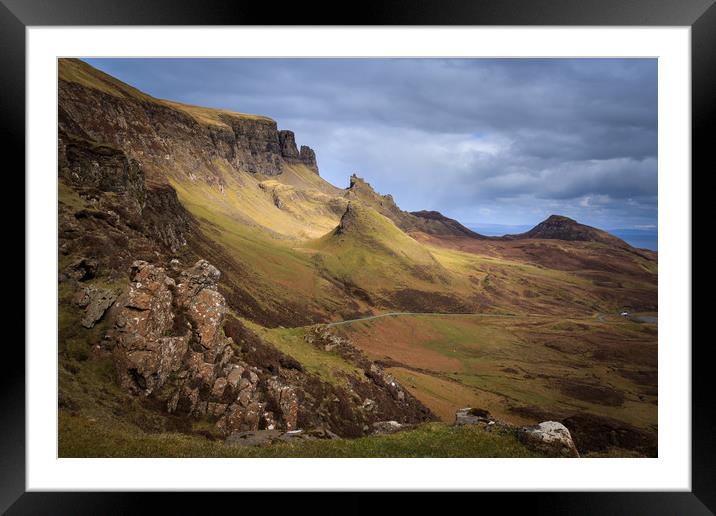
324, 314, 657, 431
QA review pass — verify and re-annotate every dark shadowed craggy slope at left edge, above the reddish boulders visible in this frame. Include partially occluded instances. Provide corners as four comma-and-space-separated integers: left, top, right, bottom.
58, 132, 192, 271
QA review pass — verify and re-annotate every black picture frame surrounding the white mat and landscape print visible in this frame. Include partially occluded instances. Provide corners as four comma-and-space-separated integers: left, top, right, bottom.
0, 0, 716, 515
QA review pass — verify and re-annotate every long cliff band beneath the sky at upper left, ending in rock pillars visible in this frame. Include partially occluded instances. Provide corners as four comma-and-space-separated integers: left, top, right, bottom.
59, 60, 318, 184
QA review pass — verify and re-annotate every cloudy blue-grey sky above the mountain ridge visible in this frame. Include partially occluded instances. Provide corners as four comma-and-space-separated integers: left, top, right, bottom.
86, 59, 657, 230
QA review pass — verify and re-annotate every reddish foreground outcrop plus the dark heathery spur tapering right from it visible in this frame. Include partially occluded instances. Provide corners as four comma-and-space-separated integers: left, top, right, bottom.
106, 260, 432, 437
